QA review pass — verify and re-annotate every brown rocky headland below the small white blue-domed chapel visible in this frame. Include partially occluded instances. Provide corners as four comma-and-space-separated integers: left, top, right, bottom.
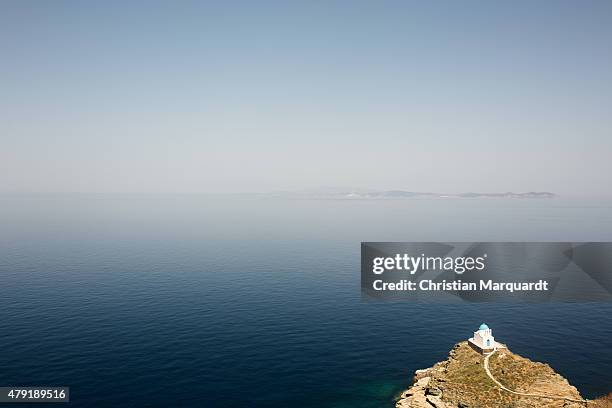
396, 342, 590, 408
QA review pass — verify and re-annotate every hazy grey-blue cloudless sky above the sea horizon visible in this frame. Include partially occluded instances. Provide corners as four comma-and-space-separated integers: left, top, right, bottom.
0, 0, 612, 194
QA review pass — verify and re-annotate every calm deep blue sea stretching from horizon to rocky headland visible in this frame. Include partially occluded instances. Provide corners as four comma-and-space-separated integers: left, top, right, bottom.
0, 195, 612, 408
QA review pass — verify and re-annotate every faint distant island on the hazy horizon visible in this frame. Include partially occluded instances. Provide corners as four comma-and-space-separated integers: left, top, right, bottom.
267, 189, 557, 200
